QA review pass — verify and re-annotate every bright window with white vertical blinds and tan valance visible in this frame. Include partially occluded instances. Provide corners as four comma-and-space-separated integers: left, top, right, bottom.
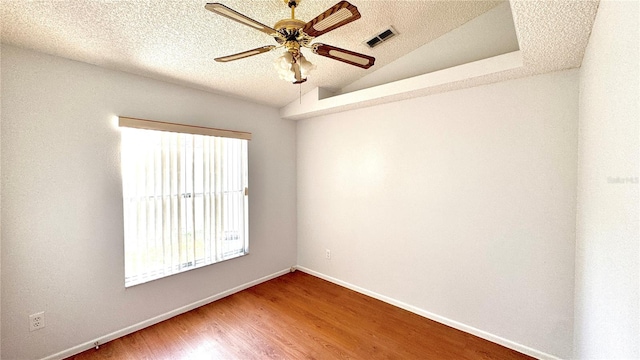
120, 117, 251, 287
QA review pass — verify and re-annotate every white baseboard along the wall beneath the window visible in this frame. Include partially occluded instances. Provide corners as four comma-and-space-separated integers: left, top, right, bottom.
42, 268, 293, 360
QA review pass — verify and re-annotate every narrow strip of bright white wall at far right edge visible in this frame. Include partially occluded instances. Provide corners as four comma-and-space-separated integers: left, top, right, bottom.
574, 1, 640, 359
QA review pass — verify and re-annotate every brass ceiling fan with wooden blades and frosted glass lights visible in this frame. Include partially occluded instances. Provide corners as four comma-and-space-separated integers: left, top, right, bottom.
205, 0, 376, 84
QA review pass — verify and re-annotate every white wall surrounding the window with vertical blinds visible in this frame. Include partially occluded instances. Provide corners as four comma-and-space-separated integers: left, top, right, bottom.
1, 46, 296, 359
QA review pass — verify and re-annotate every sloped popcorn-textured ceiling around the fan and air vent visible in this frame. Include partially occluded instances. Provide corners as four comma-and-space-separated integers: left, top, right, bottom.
0, 0, 501, 107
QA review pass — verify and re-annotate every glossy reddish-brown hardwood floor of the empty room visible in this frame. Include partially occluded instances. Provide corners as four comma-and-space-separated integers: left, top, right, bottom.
69, 271, 532, 360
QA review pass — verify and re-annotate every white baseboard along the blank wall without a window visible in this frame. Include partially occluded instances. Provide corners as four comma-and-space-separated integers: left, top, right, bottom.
295, 266, 560, 360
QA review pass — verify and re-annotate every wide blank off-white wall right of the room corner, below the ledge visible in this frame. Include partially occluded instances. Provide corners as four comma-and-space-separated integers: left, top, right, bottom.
297, 70, 578, 358
